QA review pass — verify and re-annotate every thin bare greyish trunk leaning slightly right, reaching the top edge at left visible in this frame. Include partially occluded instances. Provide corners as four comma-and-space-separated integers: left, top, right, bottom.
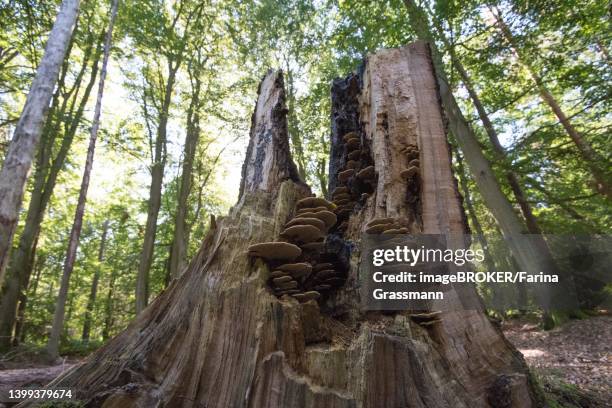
47, 0, 118, 360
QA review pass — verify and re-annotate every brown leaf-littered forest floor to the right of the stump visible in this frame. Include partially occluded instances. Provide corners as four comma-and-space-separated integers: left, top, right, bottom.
502, 316, 612, 406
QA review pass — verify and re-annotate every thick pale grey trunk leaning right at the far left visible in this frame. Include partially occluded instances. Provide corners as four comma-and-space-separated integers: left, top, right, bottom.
0, 0, 79, 284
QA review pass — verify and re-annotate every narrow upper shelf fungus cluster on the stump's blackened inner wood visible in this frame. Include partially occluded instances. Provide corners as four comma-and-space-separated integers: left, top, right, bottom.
332, 132, 376, 232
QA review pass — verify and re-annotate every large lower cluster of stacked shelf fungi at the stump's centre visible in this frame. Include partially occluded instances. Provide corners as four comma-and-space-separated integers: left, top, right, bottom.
249, 197, 346, 302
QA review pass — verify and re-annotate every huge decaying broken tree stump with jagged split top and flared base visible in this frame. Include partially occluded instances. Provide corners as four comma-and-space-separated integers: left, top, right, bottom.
27, 43, 536, 408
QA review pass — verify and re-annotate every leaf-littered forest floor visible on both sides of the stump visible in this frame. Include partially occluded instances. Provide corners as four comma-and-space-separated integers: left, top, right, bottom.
0, 316, 612, 407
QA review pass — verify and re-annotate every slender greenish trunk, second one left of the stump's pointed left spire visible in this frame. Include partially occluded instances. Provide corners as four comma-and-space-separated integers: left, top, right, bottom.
136, 59, 180, 315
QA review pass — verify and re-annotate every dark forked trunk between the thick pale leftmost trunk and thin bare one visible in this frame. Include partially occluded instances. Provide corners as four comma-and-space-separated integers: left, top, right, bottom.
0, 32, 101, 348
